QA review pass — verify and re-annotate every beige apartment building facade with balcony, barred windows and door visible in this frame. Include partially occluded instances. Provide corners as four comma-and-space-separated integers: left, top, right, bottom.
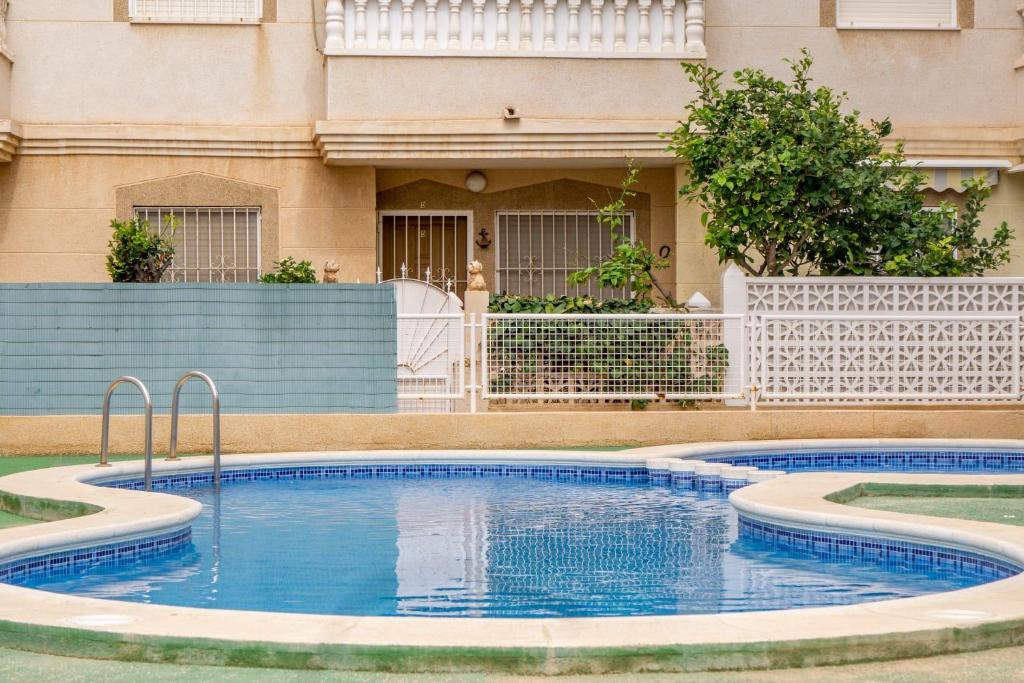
0, 0, 1024, 301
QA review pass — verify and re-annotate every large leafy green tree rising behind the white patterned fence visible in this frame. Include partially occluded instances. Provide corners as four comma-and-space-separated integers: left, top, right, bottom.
670, 49, 1013, 275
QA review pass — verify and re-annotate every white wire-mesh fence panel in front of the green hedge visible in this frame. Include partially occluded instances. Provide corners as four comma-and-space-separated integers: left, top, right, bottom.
482, 313, 742, 400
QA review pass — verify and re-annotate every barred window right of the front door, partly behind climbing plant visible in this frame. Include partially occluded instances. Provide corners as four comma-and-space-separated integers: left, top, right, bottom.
495, 211, 636, 299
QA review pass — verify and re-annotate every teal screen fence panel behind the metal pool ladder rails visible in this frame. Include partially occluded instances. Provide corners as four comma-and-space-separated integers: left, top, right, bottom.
0, 284, 397, 415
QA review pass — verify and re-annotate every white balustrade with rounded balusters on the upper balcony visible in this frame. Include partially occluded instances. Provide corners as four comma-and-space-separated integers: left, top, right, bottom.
323, 0, 707, 59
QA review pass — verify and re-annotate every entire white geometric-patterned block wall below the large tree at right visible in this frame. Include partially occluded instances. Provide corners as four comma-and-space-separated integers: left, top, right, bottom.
724, 272, 1024, 402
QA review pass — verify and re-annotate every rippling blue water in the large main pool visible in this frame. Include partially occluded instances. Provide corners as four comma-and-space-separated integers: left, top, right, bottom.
17, 477, 982, 616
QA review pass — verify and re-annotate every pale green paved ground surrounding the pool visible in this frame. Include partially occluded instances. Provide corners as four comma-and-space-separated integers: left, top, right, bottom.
0, 456, 1024, 683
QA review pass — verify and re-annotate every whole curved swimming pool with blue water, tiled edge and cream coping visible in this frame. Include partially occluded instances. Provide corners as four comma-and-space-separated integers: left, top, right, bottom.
0, 439, 1024, 674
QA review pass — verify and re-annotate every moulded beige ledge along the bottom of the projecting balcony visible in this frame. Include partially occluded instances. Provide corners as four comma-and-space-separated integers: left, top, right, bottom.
314, 119, 678, 168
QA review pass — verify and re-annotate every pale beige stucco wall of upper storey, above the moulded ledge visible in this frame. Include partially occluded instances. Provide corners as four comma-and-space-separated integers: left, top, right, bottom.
8, 0, 1024, 127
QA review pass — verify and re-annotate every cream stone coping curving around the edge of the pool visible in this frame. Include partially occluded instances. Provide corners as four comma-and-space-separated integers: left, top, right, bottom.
0, 439, 1024, 673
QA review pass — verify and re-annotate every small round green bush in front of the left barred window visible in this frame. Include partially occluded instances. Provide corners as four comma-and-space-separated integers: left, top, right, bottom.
106, 216, 177, 283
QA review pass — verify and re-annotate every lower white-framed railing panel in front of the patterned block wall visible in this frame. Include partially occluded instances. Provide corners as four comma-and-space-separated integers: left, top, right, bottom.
759, 313, 1020, 400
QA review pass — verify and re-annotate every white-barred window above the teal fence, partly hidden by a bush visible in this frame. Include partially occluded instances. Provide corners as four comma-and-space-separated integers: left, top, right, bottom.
135, 207, 260, 283
